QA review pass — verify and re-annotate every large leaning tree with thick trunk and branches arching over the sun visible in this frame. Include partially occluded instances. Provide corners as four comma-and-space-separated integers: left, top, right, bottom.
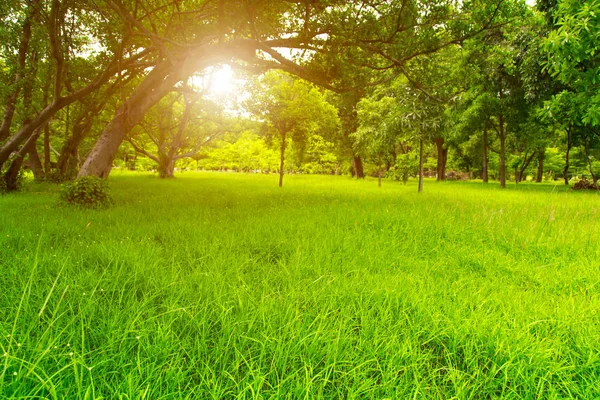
72, 0, 512, 176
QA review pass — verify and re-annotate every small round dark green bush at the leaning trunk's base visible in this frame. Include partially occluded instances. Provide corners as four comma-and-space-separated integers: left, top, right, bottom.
61, 176, 112, 208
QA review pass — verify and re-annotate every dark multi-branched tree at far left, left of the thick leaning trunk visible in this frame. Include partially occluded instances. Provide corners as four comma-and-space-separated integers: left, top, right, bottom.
0, 0, 152, 189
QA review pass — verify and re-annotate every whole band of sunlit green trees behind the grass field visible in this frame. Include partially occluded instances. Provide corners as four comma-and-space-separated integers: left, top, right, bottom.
0, 0, 600, 191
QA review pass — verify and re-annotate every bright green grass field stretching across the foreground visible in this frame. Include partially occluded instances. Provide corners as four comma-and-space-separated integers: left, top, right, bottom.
0, 173, 600, 399
